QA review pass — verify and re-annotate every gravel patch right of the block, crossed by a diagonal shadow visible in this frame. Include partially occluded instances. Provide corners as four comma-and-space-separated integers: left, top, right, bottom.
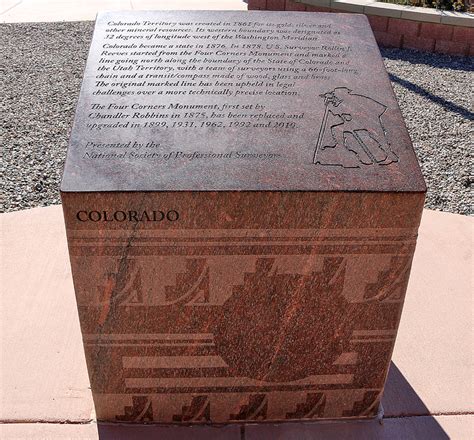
382, 49, 474, 215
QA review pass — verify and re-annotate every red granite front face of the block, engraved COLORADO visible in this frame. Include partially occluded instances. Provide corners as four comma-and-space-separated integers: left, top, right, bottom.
62, 191, 424, 423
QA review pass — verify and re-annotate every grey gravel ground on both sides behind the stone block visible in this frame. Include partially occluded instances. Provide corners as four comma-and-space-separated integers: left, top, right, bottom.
0, 22, 474, 214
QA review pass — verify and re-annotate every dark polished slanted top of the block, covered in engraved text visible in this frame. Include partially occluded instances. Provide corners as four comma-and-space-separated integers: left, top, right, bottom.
61, 11, 425, 192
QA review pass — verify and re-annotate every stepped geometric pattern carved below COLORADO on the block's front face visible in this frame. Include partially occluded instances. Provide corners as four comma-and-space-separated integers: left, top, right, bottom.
70, 229, 416, 422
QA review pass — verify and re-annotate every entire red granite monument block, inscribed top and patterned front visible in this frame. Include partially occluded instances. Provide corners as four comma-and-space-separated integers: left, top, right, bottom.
61, 11, 426, 423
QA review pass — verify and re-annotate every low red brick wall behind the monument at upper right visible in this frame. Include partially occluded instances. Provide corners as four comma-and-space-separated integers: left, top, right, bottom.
248, 0, 474, 56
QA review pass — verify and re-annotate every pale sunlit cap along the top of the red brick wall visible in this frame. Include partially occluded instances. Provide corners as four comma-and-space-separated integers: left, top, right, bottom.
293, 0, 474, 27
